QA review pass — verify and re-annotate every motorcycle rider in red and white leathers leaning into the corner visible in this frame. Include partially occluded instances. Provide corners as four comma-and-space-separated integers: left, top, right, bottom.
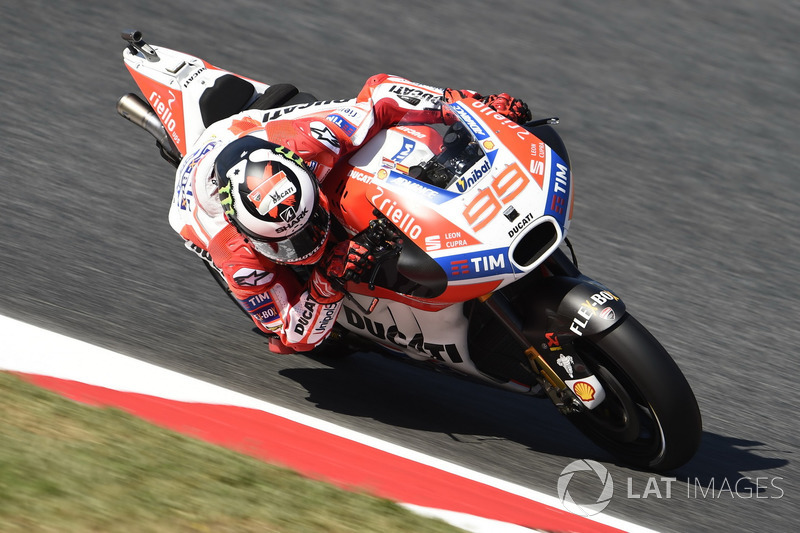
169, 74, 531, 353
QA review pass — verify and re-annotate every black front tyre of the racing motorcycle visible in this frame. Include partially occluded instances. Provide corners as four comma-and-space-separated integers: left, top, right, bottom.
569, 315, 702, 471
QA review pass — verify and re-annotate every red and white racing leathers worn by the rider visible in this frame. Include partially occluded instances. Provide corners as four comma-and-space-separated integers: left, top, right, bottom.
169, 74, 474, 351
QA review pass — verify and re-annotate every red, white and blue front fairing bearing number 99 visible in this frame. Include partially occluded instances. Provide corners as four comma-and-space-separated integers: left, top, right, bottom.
324, 99, 572, 309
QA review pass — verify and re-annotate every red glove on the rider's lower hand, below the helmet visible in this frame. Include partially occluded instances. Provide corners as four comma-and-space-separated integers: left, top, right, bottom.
311, 241, 375, 303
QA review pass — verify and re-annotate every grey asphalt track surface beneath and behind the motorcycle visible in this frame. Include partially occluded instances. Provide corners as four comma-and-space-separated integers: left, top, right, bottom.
0, 0, 800, 531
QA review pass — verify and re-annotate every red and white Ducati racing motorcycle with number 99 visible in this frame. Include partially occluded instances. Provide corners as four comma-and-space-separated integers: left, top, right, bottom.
117, 31, 702, 471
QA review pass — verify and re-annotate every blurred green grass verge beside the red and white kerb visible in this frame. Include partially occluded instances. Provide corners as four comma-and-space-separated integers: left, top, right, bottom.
0, 372, 458, 533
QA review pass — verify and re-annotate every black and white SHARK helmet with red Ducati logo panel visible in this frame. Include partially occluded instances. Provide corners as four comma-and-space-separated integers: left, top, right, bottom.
214, 136, 330, 264
